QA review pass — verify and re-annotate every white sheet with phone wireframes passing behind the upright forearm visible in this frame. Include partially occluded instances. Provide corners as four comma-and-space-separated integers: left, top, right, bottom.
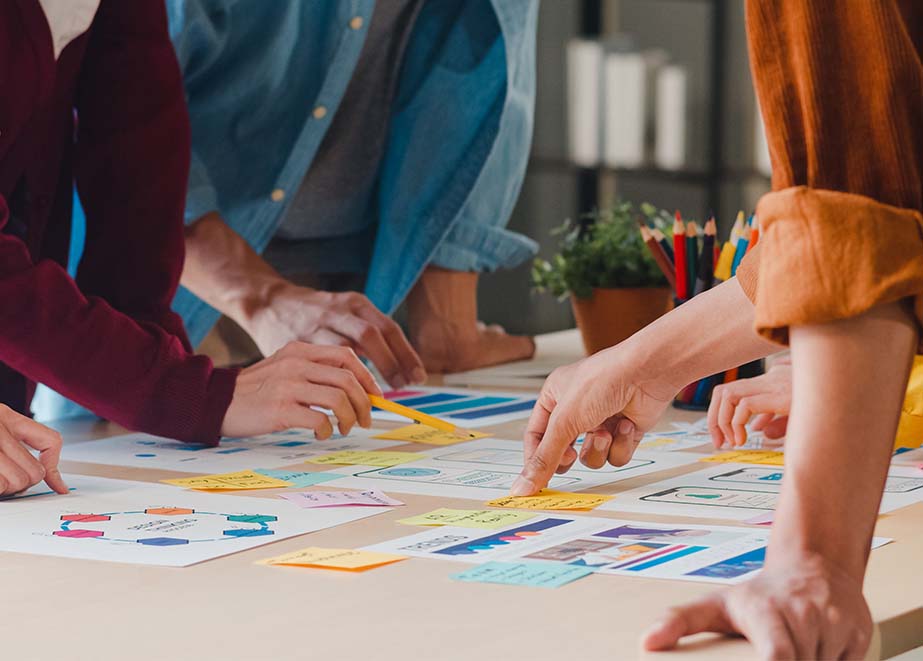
599, 463, 923, 521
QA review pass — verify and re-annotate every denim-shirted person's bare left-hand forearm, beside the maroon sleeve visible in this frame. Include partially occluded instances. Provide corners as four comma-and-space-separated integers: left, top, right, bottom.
180, 212, 288, 328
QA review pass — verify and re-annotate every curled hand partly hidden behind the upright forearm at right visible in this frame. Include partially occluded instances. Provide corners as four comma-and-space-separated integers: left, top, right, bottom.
708, 358, 792, 448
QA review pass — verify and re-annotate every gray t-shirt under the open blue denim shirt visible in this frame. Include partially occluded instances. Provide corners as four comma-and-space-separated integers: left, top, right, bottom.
266, 0, 423, 273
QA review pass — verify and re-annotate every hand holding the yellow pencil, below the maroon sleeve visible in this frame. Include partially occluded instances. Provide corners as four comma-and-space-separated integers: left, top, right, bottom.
221, 342, 381, 439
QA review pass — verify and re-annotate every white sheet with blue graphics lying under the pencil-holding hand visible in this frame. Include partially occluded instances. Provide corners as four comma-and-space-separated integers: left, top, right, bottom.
61, 428, 399, 473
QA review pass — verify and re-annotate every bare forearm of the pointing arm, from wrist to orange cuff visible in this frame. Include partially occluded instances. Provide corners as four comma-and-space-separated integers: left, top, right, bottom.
618, 279, 780, 391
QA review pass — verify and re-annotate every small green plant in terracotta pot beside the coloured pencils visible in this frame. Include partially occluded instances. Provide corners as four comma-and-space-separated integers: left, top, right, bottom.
532, 202, 671, 354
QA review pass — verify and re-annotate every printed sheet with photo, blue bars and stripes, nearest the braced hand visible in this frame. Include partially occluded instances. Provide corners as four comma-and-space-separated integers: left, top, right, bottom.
365, 514, 890, 583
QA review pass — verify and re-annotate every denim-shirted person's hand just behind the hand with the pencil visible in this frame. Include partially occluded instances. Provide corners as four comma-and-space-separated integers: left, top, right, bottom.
251, 283, 426, 388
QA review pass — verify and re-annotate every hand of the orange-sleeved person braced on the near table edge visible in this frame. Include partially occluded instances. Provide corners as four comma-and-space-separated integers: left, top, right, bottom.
642, 555, 872, 659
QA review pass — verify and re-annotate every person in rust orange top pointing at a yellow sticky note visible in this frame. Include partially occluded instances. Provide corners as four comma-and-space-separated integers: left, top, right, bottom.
513, 0, 923, 659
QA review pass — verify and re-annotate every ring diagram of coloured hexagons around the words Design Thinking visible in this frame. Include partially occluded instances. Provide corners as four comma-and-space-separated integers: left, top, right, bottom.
51, 507, 278, 547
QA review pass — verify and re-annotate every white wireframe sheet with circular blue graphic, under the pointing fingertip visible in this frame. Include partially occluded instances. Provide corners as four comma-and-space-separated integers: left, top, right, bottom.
314, 438, 701, 501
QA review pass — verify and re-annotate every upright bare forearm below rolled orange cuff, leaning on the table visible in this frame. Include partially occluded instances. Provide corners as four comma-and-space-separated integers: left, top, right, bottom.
768, 303, 917, 579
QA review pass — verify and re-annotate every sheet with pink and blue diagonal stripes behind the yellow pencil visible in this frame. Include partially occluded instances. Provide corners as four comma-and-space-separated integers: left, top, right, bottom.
372, 386, 536, 428
